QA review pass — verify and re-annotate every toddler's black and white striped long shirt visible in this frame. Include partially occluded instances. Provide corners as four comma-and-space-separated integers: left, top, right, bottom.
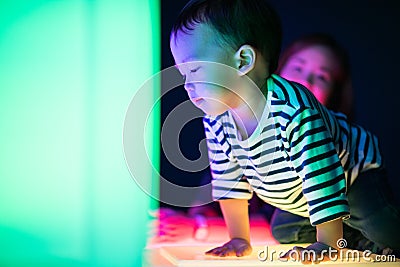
203, 75, 382, 225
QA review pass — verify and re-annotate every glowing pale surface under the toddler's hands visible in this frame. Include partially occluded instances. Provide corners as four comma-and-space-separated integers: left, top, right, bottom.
145, 218, 400, 267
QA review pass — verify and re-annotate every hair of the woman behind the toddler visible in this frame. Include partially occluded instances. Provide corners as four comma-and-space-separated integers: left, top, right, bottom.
276, 33, 353, 117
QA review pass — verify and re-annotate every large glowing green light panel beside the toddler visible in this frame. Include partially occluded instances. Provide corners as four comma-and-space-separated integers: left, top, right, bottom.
0, 0, 160, 267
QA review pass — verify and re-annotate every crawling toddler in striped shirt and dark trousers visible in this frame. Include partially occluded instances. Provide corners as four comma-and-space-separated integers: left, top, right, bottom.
170, 0, 400, 260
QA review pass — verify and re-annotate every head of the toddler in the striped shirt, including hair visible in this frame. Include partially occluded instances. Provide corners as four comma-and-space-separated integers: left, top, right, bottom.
170, 0, 281, 115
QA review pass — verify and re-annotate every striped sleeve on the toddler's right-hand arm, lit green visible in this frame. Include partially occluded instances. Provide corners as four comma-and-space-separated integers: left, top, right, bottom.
286, 108, 349, 225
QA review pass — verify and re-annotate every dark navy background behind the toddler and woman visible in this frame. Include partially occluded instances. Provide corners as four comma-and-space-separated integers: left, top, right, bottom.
161, 0, 400, 207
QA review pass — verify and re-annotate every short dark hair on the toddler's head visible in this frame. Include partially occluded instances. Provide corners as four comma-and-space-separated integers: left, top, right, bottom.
171, 0, 282, 74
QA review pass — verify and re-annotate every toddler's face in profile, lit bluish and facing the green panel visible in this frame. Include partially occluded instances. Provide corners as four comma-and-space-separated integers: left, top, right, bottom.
170, 23, 240, 115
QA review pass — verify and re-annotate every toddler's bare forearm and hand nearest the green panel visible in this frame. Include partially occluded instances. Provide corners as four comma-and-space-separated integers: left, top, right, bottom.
206, 199, 252, 257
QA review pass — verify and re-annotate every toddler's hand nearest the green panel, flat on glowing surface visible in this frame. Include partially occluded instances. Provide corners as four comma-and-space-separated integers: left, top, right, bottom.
206, 238, 253, 257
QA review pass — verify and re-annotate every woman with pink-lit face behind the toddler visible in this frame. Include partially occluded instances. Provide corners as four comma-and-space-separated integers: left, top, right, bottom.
277, 33, 352, 117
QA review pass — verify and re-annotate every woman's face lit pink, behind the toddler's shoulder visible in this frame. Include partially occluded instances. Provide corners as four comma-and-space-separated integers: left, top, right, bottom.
279, 45, 339, 105
